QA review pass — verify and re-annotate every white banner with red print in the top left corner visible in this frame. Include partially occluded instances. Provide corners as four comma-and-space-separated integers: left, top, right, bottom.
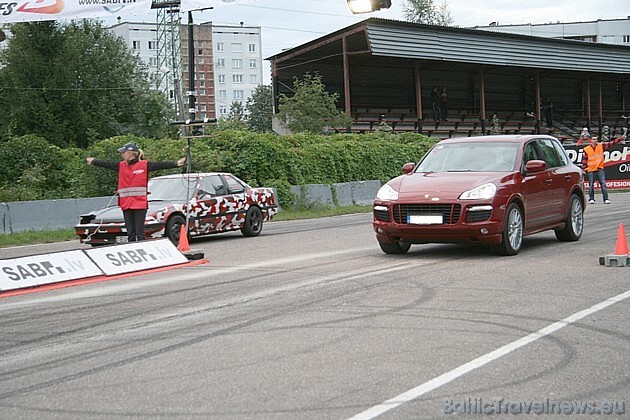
0, 0, 152, 24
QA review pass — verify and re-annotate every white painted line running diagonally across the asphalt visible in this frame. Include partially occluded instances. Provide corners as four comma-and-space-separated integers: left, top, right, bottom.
348, 290, 630, 420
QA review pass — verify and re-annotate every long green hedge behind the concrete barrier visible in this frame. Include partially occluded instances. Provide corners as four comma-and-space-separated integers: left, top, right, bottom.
0, 131, 436, 205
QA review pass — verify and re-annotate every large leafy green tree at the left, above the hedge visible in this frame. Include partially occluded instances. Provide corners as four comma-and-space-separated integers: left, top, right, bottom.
0, 20, 172, 148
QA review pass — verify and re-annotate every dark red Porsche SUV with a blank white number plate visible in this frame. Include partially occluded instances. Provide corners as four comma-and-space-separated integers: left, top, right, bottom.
372, 135, 585, 255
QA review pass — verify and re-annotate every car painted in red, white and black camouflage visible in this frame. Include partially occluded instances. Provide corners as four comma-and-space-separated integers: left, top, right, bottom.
74, 172, 278, 246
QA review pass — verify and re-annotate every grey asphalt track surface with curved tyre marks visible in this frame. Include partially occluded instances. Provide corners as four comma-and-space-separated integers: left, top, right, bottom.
0, 193, 630, 419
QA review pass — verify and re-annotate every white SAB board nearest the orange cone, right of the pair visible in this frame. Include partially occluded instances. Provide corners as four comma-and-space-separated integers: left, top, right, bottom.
85, 238, 188, 276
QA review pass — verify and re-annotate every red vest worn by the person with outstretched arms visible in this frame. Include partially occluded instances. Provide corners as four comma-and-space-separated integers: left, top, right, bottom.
117, 160, 149, 210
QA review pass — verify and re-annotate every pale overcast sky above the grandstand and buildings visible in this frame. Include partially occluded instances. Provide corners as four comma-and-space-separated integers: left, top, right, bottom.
101, 0, 630, 83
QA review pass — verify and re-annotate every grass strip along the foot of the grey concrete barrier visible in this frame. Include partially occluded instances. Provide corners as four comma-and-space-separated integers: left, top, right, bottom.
0, 206, 372, 248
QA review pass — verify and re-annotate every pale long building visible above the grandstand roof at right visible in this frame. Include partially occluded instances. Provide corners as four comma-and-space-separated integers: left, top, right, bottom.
473, 16, 630, 45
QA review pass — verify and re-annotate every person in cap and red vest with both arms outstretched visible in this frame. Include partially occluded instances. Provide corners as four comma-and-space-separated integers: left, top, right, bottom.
86, 143, 186, 242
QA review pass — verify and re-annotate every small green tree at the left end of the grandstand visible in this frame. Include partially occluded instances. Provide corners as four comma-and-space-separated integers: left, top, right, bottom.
278, 73, 352, 134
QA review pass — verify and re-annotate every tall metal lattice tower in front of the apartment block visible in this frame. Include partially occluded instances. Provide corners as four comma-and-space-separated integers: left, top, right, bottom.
152, 0, 186, 119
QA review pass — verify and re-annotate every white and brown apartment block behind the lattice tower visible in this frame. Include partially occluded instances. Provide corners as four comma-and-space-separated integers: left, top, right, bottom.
108, 22, 263, 119
